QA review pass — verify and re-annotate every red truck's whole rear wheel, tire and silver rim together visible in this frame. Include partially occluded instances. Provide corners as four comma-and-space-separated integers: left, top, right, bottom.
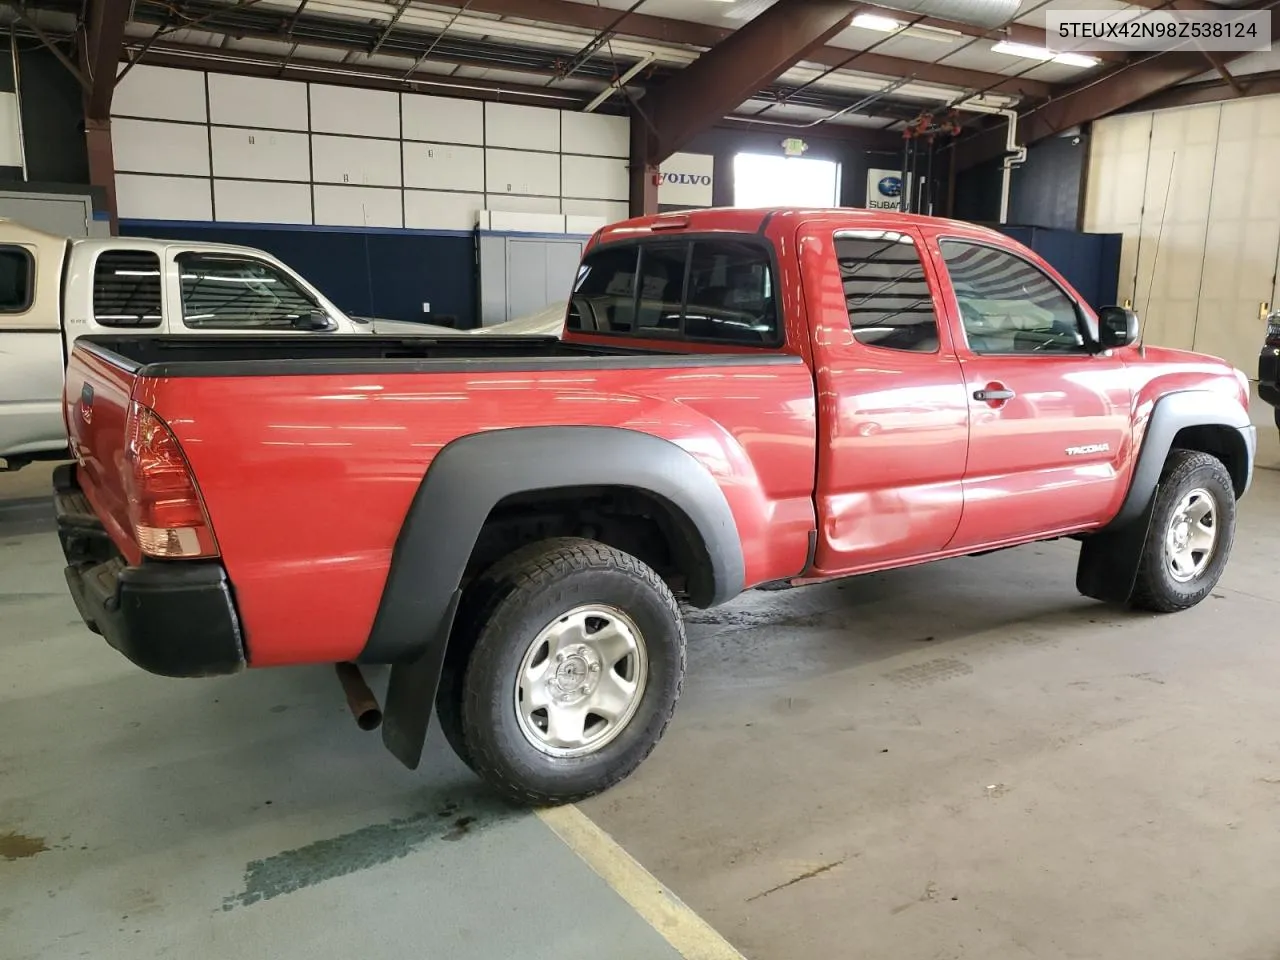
458, 539, 685, 805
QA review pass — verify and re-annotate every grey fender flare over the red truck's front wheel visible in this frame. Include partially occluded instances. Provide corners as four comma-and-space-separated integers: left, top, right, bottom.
1107, 390, 1257, 530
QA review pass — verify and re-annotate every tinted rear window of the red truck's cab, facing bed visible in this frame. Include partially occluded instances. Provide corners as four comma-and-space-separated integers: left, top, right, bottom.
568, 237, 781, 346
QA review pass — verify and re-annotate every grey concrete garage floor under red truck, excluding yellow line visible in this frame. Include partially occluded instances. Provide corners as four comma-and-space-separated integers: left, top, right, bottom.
0, 445, 1280, 960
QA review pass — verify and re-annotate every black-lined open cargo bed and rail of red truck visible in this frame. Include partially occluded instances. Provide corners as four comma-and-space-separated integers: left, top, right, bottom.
78, 335, 797, 378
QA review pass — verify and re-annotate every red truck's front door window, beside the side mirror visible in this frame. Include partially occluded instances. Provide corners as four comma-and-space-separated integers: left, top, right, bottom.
941, 241, 1087, 353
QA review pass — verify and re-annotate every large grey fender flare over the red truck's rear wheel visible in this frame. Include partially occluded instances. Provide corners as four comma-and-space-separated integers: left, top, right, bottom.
360, 426, 746, 663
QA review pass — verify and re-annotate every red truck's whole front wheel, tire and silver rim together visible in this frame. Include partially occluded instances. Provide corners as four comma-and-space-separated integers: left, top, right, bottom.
1130, 451, 1235, 613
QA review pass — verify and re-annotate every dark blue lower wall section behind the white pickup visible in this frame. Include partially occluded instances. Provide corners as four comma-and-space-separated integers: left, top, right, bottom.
120, 220, 477, 329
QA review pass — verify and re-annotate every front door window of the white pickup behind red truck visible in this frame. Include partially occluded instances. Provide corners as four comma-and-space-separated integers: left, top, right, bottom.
178, 253, 334, 330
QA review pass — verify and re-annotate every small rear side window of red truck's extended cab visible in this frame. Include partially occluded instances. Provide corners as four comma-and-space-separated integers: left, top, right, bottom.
836, 230, 938, 353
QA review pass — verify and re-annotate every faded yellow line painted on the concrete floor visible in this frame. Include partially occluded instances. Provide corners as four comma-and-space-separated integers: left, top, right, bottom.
538, 806, 745, 960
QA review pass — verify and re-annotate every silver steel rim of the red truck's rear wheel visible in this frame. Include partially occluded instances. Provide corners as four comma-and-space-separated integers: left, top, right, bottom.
515, 603, 649, 758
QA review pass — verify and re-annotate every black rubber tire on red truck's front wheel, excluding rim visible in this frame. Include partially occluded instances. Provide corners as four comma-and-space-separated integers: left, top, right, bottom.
1129, 449, 1235, 613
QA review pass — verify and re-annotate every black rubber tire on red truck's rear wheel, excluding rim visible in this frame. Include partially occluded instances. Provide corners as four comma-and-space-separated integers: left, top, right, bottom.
455, 539, 685, 806
